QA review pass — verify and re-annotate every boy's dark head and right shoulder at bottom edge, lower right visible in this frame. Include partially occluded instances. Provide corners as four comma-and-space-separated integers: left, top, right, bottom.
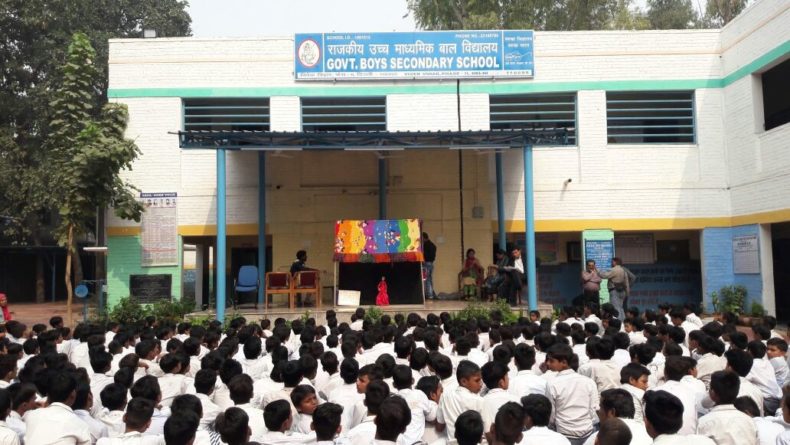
644, 390, 716, 445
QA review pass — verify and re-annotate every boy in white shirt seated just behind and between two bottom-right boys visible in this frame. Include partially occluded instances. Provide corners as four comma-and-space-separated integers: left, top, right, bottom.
660, 357, 706, 434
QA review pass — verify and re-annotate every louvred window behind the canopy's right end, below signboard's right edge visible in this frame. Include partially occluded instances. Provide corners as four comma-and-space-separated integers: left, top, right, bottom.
488, 93, 576, 145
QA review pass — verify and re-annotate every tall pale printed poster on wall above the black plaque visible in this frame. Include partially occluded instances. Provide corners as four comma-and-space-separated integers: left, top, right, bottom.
140, 192, 178, 267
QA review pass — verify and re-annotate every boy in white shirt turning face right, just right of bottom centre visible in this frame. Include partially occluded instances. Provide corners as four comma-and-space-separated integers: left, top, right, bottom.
436, 360, 483, 437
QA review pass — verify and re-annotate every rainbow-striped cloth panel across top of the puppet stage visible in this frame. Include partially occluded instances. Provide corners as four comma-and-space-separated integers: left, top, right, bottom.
334, 219, 423, 263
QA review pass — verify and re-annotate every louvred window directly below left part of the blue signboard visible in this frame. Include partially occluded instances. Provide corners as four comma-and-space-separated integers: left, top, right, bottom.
302, 96, 387, 131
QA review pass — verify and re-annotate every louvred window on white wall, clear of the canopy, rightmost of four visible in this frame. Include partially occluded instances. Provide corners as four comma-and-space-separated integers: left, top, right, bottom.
606, 91, 695, 144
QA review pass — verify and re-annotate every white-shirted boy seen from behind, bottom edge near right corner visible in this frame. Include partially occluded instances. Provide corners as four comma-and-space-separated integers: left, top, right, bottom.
697, 371, 757, 445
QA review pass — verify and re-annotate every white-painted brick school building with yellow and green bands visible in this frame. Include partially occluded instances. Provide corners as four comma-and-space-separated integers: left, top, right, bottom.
106, 0, 790, 319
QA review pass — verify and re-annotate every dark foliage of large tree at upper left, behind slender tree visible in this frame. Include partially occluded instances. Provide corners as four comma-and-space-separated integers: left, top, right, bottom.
0, 0, 191, 243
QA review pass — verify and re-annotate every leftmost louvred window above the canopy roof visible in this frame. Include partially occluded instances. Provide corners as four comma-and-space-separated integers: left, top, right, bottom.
184, 98, 269, 131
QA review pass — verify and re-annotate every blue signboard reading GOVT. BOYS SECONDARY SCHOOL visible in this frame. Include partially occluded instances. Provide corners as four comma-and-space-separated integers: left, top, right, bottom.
294, 31, 535, 80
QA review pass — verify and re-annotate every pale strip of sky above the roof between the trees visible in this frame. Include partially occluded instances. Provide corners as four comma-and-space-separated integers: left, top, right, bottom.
189, 0, 416, 37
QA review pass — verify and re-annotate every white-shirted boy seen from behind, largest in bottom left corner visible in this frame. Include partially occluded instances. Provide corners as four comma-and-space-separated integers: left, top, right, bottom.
25, 371, 91, 445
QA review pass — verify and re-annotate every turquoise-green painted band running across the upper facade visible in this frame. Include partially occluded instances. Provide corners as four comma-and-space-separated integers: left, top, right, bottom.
107, 40, 790, 99
